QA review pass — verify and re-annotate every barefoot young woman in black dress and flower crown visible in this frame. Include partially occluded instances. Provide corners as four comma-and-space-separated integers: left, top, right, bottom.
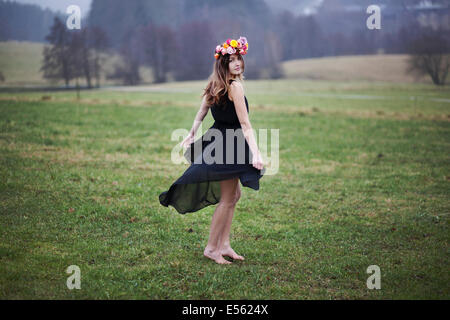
159, 37, 265, 264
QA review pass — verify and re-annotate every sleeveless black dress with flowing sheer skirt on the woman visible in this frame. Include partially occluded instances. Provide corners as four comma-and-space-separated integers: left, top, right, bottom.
159, 79, 265, 214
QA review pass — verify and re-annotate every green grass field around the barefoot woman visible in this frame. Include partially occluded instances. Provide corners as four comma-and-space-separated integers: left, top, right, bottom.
0, 80, 450, 299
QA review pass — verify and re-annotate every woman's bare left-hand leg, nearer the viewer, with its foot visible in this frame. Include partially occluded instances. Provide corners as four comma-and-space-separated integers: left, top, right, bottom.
203, 178, 239, 264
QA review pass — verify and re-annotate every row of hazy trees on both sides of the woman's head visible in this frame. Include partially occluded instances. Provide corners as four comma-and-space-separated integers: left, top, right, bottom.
107, 21, 283, 85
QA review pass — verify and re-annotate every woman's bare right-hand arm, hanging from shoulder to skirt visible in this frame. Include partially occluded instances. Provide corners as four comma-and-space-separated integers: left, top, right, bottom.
230, 81, 262, 170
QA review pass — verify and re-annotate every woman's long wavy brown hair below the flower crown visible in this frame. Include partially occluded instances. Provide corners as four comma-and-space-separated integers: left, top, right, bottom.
202, 54, 245, 106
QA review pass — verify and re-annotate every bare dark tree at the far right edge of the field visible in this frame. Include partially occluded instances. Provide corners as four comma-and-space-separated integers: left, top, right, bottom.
407, 29, 450, 85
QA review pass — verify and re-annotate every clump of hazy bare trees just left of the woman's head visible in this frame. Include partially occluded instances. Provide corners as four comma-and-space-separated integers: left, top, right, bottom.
108, 22, 216, 85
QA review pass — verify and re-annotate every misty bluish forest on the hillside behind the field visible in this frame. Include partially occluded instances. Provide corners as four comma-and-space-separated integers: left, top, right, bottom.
0, 0, 449, 84
